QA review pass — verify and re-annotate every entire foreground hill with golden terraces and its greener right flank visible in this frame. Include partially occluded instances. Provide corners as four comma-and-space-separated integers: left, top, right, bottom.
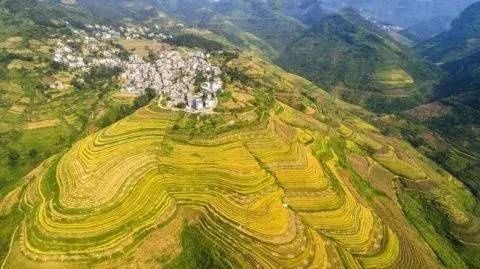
5, 46, 478, 268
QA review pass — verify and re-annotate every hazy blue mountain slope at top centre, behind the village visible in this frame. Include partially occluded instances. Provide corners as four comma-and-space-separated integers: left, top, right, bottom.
158, 0, 306, 56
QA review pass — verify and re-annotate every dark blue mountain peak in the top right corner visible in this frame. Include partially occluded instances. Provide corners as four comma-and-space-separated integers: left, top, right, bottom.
417, 2, 480, 63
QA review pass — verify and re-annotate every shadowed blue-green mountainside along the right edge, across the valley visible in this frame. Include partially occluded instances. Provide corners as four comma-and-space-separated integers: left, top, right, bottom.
405, 2, 480, 197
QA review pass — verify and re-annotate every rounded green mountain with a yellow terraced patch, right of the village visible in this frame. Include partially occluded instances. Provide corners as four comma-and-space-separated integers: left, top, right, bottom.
278, 10, 436, 111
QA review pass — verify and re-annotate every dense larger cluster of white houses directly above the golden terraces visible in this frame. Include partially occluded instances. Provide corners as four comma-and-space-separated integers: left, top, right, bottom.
120, 50, 223, 112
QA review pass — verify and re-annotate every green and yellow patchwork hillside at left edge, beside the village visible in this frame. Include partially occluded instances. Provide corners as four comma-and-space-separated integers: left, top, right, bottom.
0, 1, 119, 195
